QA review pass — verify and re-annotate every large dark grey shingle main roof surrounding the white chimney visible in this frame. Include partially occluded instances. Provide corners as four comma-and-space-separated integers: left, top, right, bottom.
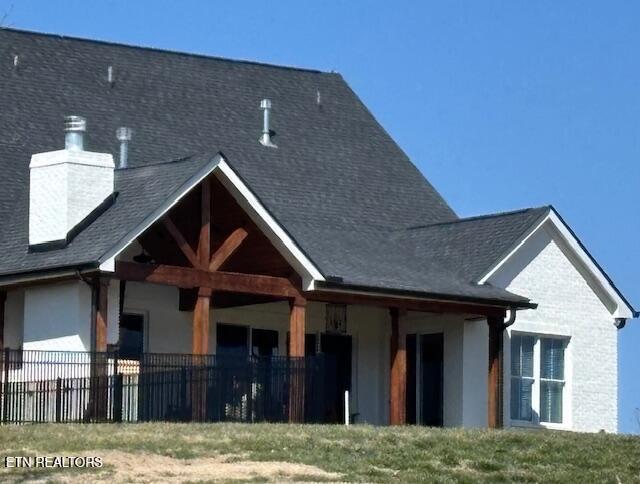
0, 30, 536, 301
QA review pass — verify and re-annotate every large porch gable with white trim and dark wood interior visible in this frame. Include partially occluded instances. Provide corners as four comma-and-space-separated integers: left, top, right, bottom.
100, 155, 324, 288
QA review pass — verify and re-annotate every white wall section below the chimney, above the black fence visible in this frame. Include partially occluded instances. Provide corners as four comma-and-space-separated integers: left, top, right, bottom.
23, 281, 91, 351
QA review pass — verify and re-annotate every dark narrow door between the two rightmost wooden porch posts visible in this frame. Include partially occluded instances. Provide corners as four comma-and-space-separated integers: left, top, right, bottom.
420, 333, 444, 427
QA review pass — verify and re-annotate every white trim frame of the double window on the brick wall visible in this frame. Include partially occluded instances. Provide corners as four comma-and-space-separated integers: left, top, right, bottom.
504, 330, 573, 430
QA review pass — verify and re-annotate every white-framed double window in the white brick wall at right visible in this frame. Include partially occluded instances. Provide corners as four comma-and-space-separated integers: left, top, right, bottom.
511, 333, 567, 424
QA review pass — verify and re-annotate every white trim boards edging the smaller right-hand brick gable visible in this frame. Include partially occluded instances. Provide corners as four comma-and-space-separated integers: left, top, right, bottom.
478, 206, 639, 319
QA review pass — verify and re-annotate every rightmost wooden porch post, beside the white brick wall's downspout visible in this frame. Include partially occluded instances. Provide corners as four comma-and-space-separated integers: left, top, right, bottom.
487, 316, 504, 429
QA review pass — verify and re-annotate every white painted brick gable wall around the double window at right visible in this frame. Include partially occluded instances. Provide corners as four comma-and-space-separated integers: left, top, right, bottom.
490, 223, 618, 432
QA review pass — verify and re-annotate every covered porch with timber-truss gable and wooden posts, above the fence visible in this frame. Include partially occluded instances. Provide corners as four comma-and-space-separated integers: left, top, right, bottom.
106, 171, 506, 427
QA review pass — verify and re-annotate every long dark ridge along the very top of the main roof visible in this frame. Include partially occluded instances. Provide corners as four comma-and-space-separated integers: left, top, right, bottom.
0, 27, 330, 75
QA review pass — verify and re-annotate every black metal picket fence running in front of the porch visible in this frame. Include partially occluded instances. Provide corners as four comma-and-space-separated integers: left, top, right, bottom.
0, 349, 335, 423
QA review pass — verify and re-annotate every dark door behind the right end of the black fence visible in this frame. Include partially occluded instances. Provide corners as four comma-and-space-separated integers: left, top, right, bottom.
320, 334, 351, 423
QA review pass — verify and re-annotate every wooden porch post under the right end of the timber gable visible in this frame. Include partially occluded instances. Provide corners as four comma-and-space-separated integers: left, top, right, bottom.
289, 298, 306, 423
